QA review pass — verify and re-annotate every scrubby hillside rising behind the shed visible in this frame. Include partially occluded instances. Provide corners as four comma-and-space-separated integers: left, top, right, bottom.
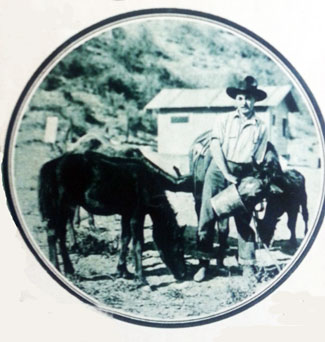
19, 20, 312, 151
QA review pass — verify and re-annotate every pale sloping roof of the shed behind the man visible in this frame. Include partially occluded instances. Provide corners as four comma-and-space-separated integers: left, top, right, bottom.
145, 84, 291, 109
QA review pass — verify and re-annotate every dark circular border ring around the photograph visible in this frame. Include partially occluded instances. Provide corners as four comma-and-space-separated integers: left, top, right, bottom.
2, 8, 325, 328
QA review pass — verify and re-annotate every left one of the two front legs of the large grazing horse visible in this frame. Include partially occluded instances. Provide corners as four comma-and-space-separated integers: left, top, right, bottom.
117, 215, 132, 279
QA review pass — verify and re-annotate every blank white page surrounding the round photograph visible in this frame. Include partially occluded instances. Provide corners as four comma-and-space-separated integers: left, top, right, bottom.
0, 0, 325, 342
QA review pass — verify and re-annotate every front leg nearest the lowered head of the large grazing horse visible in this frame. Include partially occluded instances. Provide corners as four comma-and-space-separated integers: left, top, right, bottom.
130, 213, 147, 285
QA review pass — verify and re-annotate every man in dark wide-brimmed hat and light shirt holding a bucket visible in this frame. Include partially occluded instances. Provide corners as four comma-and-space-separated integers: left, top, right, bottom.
194, 76, 268, 281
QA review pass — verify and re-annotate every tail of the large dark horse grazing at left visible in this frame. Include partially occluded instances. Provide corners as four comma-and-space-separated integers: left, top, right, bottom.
38, 161, 59, 221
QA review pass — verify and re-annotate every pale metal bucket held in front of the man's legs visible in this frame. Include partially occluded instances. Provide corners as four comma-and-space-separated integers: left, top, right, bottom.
210, 184, 247, 218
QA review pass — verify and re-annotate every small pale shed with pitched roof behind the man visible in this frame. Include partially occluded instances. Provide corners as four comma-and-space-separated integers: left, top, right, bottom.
145, 85, 298, 156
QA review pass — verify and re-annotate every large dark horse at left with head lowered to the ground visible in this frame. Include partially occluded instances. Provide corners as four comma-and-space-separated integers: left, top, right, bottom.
39, 152, 186, 283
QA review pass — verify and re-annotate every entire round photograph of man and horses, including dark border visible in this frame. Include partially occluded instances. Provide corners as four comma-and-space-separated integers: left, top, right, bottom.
4, 10, 324, 327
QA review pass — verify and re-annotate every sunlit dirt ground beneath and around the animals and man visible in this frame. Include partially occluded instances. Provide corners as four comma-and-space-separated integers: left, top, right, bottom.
10, 132, 321, 322
